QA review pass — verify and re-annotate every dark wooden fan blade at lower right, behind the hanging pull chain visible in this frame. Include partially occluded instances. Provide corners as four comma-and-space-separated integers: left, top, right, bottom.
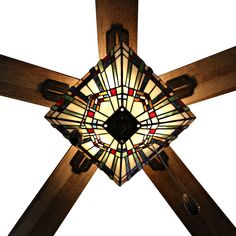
144, 147, 236, 235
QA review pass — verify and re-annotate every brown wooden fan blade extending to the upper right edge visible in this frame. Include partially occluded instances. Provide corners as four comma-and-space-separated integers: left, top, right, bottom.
160, 47, 236, 104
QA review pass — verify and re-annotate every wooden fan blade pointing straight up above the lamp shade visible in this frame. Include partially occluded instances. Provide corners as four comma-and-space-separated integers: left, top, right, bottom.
96, 0, 138, 58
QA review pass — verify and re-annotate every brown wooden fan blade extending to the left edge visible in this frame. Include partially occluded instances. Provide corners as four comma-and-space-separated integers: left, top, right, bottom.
0, 55, 78, 107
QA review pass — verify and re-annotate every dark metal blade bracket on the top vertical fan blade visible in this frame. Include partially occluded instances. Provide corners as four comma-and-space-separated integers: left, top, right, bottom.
106, 24, 129, 54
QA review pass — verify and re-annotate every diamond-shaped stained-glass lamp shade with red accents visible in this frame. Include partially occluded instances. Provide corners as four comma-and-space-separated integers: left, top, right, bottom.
45, 43, 195, 185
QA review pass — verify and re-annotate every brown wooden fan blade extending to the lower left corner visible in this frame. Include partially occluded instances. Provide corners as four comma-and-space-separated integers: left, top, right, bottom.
9, 146, 97, 236
